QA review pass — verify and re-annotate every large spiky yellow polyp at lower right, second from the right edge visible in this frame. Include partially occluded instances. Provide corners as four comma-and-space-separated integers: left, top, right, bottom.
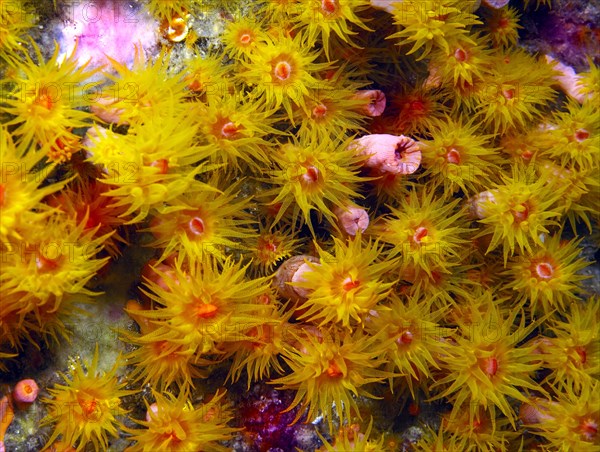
431, 304, 543, 428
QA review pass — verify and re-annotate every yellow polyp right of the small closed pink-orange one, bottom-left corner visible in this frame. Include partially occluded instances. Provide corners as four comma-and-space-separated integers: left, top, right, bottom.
42, 348, 135, 451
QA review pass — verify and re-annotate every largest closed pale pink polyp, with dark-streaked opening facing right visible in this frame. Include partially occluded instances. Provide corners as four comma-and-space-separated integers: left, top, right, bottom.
352, 134, 421, 174
